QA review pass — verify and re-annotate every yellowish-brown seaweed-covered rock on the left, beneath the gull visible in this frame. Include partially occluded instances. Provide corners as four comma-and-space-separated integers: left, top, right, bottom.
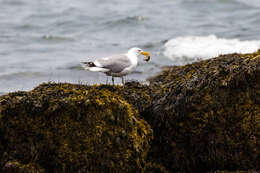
0, 83, 152, 172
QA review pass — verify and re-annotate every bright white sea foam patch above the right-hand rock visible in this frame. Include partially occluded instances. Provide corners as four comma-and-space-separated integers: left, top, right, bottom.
163, 35, 260, 64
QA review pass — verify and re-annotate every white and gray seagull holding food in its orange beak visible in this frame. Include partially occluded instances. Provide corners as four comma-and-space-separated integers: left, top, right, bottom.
81, 47, 150, 85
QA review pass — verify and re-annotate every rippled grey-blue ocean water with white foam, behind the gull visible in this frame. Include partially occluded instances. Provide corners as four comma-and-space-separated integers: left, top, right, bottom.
0, 0, 260, 94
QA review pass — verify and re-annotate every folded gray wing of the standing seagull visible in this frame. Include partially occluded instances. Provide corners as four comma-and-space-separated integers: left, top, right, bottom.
94, 55, 131, 73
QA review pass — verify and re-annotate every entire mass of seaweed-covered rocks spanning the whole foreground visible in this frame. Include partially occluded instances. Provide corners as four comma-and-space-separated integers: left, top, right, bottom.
0, 51, 260, 173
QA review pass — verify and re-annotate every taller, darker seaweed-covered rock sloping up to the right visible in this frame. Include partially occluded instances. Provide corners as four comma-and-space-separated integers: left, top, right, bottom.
142, 51, 260, 172
